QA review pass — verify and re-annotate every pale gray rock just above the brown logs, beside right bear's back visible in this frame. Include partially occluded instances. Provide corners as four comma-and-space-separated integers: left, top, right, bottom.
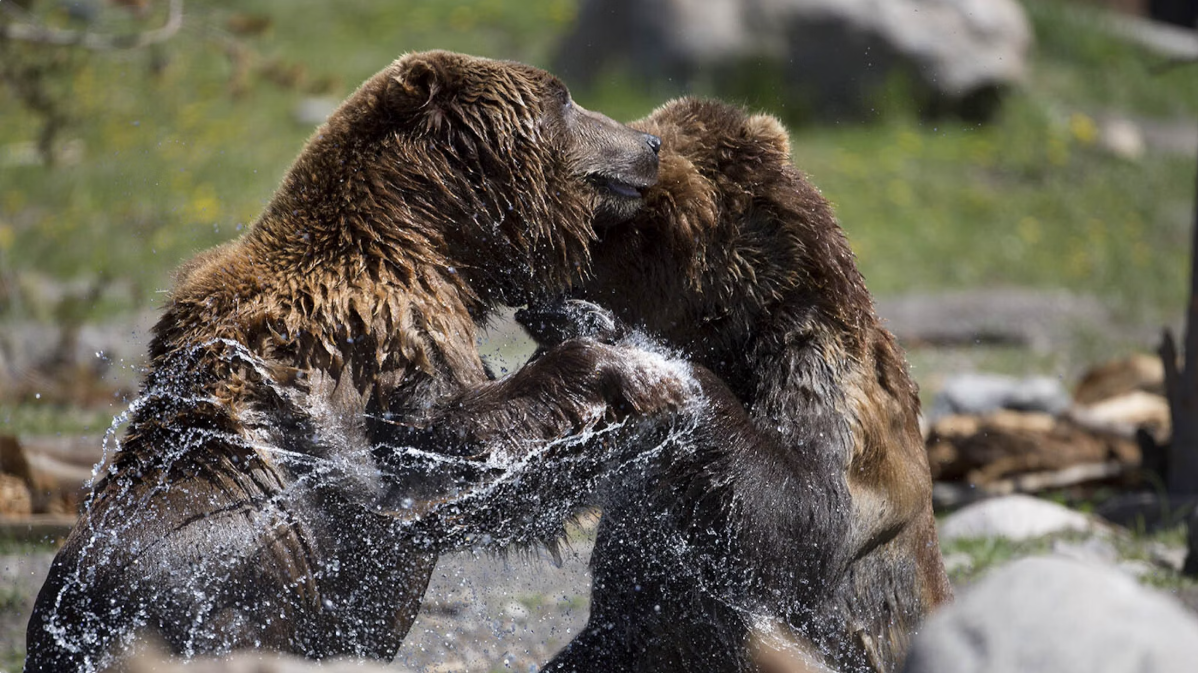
927, 374, 1071, 423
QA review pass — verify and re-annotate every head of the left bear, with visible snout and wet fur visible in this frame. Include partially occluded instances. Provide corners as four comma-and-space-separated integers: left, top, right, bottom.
258, 51, 660, 310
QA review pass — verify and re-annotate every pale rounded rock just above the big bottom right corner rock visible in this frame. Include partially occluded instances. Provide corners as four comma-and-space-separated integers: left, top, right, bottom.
939, 495, 1101, 541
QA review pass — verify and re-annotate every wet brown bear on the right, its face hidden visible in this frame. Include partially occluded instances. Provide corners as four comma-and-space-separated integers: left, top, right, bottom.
518, 99, 951, 672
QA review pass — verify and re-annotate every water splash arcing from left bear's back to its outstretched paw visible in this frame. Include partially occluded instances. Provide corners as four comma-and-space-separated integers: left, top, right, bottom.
30, 330, 785, 671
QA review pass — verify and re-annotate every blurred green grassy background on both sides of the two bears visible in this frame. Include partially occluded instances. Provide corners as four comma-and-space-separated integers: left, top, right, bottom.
0, 0, 1198, 385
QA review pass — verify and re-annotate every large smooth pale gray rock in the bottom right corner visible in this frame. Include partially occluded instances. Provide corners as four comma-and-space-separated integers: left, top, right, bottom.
903, 558, 1198, 673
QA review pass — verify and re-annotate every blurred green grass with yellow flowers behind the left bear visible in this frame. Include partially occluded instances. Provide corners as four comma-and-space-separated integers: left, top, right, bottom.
0, 0, 575, 317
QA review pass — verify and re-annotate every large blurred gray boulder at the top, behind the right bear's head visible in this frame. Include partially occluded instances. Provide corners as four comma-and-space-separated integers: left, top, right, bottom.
553, 0, 1031, 117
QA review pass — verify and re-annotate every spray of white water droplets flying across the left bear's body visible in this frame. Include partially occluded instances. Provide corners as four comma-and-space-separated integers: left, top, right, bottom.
32, 330, 752, 671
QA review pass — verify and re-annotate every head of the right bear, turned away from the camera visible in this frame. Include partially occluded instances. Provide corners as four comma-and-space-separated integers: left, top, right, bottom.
574, 98, 872, 354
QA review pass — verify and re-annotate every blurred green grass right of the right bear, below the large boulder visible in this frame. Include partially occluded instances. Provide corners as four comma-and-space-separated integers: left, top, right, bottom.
794, 96, 1193, 325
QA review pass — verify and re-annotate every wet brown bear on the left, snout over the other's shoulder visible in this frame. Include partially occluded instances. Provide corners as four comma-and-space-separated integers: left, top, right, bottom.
25, 53, 671, 672
